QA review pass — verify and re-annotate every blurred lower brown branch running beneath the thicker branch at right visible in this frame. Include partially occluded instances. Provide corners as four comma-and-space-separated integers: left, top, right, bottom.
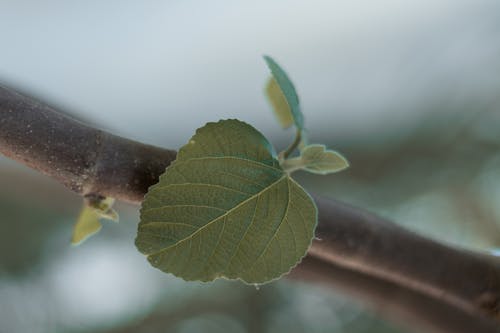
290, 255, 499, 333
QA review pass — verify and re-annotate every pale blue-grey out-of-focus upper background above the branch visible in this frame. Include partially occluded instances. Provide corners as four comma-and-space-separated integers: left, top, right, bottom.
0, 0, 500, 148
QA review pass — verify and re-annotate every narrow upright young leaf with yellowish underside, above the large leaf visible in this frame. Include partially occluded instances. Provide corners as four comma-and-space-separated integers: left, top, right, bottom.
264, 56, 304, 130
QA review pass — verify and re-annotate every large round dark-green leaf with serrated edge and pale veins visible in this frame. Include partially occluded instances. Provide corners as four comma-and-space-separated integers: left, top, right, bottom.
136, 120, 317, 283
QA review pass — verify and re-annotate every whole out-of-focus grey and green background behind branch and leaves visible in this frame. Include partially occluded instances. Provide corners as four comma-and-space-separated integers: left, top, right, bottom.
0, 0, 500, 333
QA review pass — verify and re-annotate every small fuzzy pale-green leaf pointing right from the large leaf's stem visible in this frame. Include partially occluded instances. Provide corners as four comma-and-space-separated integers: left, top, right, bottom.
301, 144, 349, 175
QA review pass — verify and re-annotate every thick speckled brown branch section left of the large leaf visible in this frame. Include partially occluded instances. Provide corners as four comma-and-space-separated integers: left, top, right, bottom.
0, 86, 176, 202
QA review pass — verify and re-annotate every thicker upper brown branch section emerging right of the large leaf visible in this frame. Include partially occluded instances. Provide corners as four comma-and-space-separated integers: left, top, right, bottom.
309, 198, 500, 319
